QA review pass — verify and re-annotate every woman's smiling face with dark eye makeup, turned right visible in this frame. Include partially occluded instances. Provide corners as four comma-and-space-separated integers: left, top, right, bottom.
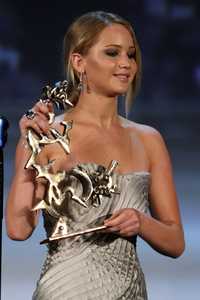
83, 24, 137, 96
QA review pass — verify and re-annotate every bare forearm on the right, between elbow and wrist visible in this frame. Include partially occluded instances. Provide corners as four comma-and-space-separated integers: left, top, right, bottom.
139, 213, 185, 258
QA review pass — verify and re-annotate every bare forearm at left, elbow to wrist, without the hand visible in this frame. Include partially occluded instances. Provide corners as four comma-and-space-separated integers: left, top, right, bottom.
6, 137, 36, 240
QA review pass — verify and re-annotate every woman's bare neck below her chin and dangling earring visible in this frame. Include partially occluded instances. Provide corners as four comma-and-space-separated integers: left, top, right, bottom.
71, 93, 118, 128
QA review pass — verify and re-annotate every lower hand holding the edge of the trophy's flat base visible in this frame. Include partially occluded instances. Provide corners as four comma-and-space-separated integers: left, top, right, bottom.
104, 208, 141, 237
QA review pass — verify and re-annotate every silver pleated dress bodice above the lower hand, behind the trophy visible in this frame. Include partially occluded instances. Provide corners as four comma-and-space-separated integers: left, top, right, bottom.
44, 162, 150, 244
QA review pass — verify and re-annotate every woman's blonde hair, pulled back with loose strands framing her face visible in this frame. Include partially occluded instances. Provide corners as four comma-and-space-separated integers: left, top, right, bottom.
63, 11, 142, 113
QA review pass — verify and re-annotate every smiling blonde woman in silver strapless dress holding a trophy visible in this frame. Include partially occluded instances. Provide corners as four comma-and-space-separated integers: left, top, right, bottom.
6, 12, 184, 300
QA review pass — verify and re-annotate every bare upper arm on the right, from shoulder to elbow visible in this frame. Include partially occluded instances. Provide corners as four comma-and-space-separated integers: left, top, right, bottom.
141, 128, 181, 225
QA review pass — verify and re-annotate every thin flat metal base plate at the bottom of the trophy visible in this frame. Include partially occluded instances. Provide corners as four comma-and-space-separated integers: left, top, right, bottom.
40, 225, 107, 245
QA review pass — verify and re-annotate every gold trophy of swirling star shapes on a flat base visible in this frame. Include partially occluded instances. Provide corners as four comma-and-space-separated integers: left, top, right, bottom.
25, 80, 119, 244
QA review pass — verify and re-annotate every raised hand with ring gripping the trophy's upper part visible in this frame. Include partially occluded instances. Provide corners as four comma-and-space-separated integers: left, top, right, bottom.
19, 101, 53, 137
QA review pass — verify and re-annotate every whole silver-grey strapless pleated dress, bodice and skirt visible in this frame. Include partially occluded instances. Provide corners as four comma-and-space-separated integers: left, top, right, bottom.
32, 163, 150, 300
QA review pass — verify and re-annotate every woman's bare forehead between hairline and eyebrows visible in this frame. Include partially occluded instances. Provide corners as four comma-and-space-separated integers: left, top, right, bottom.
96, 24, 134, 47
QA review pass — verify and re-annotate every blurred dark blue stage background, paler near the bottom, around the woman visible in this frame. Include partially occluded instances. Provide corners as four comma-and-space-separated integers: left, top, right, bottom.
0, 0, 200, 300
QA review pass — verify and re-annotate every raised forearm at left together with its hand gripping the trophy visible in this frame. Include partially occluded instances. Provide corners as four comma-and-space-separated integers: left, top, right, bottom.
6, 102, 52, 240
